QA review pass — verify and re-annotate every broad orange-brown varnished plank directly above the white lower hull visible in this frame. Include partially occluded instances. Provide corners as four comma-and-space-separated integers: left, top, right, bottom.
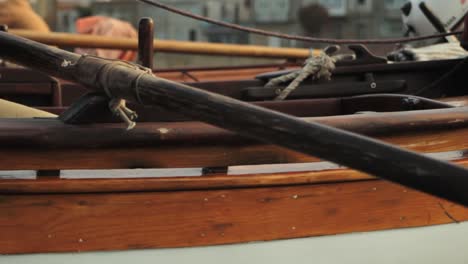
0, 181, 468, 254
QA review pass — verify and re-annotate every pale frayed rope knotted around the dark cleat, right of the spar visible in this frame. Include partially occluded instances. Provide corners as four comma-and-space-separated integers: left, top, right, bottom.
265, 45, 353, 100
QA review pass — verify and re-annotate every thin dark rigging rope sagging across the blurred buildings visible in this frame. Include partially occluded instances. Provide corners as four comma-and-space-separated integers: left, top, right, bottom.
138, 0, 463, 45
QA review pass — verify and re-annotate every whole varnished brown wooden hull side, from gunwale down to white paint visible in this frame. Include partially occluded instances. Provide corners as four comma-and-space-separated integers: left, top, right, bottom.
0, 104, 468, 254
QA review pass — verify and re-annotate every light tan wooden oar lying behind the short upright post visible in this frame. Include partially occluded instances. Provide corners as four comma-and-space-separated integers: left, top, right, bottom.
9, 30, 320, 59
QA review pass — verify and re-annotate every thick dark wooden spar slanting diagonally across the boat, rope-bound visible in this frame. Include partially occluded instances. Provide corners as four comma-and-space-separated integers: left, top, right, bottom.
0, 33, 468, 205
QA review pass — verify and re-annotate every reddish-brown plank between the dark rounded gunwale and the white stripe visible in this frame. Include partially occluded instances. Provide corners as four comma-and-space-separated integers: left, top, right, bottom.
0, 128, 468, 170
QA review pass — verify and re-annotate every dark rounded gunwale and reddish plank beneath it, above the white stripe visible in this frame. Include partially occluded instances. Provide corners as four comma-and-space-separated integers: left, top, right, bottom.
0, 108, 468, 170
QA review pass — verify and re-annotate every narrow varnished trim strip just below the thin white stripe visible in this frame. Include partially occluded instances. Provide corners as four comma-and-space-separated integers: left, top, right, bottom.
0, 159, 468, 194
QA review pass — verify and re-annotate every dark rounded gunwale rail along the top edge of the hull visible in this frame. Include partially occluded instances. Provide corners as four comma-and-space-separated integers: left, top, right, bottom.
0, 106, 468, 150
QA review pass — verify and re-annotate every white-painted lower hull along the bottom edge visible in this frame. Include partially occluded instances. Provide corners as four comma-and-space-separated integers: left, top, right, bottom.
0, 223, 468, 264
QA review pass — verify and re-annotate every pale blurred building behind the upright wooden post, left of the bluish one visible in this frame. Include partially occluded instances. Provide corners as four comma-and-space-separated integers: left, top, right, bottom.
91, 0, 251, 44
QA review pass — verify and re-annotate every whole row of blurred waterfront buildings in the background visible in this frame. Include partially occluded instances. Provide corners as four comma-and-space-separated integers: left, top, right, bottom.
44, 0, 407, 46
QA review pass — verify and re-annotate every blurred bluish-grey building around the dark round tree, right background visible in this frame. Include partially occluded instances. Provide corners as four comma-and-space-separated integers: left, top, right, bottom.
252, 0, 407, 46
